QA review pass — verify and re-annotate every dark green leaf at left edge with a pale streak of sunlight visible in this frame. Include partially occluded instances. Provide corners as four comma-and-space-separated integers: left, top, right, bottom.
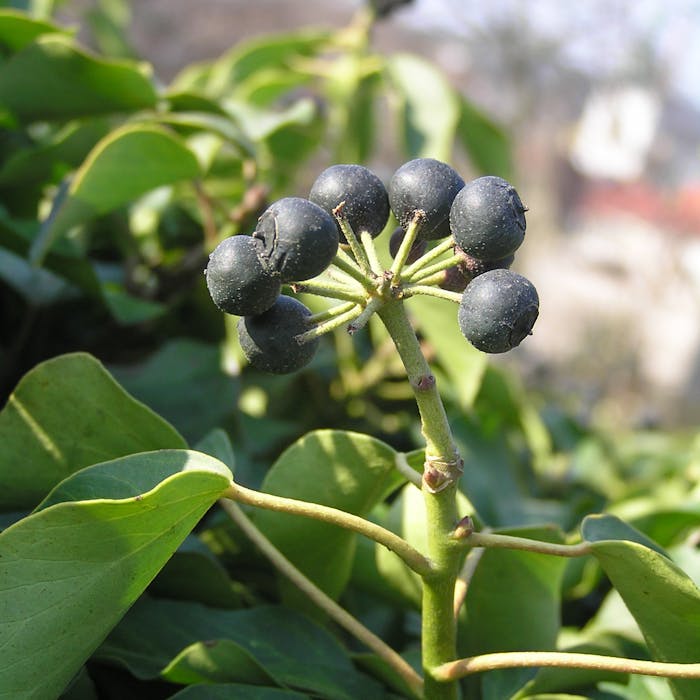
0, 353, 186, 510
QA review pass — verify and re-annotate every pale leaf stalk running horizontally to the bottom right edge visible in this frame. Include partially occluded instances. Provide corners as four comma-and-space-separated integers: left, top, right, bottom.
433, 651, 700, 681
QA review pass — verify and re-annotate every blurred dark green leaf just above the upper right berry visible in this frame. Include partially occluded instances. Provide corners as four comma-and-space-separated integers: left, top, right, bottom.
457, 98, 513, 180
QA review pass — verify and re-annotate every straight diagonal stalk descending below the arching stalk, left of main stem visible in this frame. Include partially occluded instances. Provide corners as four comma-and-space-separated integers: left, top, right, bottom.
220, 499, 423, 697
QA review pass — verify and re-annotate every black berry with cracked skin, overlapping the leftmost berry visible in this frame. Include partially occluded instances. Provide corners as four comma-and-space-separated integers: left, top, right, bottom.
253, 197, 338, 282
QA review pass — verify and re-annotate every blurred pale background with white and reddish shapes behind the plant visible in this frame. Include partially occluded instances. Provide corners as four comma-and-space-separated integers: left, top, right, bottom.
52, 0, 700, 425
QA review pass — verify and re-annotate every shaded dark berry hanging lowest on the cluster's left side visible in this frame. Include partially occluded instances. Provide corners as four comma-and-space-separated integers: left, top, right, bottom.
238, 295, 319, 374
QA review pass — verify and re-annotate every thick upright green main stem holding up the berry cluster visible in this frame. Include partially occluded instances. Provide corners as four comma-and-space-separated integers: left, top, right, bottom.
378, 301, 462, 700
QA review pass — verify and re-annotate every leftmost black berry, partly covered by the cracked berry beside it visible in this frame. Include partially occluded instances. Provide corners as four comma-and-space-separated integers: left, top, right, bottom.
204, 236, 281, 316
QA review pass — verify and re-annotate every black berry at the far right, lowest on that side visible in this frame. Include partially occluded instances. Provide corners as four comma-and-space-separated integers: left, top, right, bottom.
457, 269, 539, 353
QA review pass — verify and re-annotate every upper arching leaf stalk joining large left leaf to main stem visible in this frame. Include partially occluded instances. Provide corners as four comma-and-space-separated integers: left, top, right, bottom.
224, 483, 433, 578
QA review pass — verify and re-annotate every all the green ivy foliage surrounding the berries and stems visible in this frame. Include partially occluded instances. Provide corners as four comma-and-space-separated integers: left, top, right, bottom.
0, 2, 700, 700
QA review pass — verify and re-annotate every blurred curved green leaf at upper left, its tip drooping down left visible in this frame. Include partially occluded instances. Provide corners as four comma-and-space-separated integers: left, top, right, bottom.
31, 124, 200, 260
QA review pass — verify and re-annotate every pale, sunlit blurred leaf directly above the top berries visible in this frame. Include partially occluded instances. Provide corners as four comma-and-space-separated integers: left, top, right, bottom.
387, 53, 460, 161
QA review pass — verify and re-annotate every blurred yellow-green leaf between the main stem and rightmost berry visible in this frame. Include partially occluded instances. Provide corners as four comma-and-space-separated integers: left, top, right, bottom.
408, 296, 488, 409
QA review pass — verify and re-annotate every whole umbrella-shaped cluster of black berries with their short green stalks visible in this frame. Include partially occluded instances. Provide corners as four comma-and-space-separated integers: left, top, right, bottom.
205, 158, 539, 374
